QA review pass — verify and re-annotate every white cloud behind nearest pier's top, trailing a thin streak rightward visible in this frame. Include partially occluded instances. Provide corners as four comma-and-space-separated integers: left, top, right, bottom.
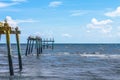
6, 16, 39, 27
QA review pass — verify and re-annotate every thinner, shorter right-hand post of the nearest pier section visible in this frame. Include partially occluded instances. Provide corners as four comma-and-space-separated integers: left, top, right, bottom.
15, 27, 22, 71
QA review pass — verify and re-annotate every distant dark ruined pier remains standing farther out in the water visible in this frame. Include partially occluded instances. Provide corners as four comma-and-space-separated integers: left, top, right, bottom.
25, 36, 54, 56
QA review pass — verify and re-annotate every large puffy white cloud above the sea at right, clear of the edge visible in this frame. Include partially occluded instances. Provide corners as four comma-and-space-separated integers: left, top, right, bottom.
87, 18, 113, 33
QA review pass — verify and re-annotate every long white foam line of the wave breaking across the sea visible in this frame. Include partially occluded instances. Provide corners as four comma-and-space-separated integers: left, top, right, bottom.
27, 52, 120, 59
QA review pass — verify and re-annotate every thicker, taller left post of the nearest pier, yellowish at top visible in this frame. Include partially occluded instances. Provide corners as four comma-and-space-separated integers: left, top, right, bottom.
4, 20, 14, 76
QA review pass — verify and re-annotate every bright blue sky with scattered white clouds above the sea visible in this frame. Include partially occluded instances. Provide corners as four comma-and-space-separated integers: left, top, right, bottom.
0, 0, 120, 43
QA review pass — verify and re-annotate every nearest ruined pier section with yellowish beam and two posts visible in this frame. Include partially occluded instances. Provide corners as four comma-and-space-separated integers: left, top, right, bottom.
0, 20, 22, 76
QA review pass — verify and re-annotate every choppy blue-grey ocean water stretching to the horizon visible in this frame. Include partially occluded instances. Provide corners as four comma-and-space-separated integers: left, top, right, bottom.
0, 44, 120, 80
